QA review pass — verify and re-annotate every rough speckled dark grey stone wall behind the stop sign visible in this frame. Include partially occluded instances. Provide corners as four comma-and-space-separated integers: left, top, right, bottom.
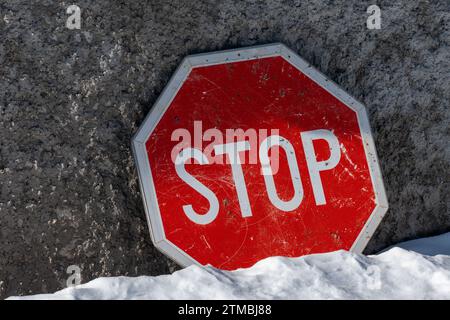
0, 0, 450, 297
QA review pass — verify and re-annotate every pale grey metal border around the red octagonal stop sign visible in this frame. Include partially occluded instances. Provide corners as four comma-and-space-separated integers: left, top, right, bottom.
132, 43, 388, 267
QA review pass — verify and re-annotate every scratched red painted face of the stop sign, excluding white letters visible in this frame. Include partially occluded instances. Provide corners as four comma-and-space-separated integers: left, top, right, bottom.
146, 57, 375, 270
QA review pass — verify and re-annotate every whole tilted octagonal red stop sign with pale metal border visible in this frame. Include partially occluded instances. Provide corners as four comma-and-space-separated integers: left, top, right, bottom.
133, 44, 388, 270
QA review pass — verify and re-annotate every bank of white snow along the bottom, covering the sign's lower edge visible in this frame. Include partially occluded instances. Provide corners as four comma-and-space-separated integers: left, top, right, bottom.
7, 233, 450, 299
